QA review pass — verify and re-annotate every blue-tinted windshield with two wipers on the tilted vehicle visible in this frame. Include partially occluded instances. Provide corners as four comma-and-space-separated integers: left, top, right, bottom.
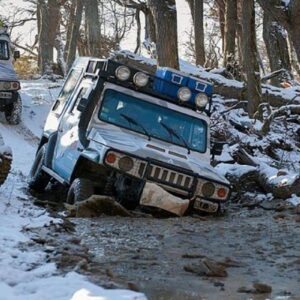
99, 89, 207, 153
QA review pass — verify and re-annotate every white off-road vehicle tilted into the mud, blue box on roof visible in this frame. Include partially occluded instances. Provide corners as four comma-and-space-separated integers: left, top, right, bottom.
29, 58, 230, 213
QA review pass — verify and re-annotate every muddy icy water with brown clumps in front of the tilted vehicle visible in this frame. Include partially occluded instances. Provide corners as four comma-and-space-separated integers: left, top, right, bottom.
26, 192, 300, 300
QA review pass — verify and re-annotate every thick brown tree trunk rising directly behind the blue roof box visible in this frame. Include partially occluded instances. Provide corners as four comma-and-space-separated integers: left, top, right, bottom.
148, 0, 179, 69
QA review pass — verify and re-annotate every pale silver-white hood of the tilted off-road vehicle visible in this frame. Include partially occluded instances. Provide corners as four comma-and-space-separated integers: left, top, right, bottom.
90, 126, 229, 184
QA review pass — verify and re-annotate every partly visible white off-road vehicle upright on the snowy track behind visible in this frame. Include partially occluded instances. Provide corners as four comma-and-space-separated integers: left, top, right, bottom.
0, 26, 22, 125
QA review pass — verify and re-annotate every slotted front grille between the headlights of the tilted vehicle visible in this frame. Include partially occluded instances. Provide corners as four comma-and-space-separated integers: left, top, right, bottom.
147, 164, 193, 190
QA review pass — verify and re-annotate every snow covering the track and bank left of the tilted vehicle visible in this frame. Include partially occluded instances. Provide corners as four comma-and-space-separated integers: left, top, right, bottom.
0, 80, 146, 300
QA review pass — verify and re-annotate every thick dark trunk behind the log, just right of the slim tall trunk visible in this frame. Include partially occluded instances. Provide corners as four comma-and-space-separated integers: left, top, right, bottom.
263, 11, 291, 85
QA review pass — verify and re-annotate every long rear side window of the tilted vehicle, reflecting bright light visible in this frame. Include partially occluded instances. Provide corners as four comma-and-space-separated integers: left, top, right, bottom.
52, 70, 81, 114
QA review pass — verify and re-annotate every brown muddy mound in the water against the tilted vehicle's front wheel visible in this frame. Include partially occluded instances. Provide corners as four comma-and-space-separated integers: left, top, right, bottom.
66, 195, 131, 218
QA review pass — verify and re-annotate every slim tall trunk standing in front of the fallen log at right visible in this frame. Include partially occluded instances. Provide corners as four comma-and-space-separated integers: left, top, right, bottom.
242, 0, 261, 117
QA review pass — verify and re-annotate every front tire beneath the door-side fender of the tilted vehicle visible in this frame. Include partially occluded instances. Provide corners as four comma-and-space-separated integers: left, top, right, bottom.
67, 178, 95, 204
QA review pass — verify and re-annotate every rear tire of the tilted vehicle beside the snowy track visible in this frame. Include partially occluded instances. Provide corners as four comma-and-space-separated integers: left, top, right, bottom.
28, 145, 50, 192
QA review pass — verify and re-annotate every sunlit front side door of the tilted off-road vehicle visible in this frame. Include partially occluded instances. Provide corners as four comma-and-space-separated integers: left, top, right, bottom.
52, 79, 92, 180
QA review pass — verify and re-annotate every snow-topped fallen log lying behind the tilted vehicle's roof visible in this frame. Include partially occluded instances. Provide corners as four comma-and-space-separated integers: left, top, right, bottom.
111, 51, 300, 107
